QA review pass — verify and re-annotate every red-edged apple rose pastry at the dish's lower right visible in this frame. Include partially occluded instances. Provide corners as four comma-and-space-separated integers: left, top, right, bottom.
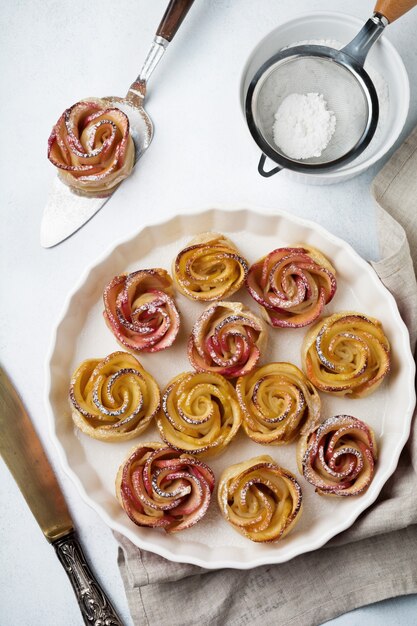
297, 415, 377, 496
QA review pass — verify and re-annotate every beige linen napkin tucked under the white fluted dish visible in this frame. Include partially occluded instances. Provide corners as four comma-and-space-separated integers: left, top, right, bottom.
116, 128, 417, 626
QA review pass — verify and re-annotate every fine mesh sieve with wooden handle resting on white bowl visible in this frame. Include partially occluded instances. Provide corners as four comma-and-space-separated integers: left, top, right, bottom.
245, 0, 417, 176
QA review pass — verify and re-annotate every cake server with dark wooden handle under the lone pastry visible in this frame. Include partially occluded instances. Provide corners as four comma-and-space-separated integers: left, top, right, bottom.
41, 0, 194, 248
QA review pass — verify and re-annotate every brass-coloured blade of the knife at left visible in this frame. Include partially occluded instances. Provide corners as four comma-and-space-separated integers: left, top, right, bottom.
0, 367, 74, 542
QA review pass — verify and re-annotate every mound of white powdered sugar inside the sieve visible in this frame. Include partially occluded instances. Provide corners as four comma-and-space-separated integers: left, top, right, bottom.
273, 93, 336, 159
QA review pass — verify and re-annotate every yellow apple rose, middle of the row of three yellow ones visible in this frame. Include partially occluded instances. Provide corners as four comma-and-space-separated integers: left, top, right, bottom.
156, 372, 242, 456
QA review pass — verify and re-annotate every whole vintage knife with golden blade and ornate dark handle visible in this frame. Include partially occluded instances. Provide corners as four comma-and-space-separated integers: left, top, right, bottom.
0, 367, 123, 626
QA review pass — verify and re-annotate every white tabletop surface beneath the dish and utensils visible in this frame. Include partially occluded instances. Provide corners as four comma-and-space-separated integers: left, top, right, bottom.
0, 0, 417, 626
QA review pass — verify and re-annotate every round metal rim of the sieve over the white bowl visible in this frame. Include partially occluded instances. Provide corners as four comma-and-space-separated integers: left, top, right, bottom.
245, 44, 379, 174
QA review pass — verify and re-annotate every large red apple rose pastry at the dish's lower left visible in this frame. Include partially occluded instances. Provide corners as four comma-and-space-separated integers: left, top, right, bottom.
116, 443, 214, 533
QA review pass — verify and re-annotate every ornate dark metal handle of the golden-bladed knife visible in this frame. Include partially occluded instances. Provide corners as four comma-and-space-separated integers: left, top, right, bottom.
52, 532, 123, 626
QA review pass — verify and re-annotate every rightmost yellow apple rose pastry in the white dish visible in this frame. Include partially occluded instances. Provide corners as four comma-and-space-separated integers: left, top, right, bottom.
302, 311, 390, 398
